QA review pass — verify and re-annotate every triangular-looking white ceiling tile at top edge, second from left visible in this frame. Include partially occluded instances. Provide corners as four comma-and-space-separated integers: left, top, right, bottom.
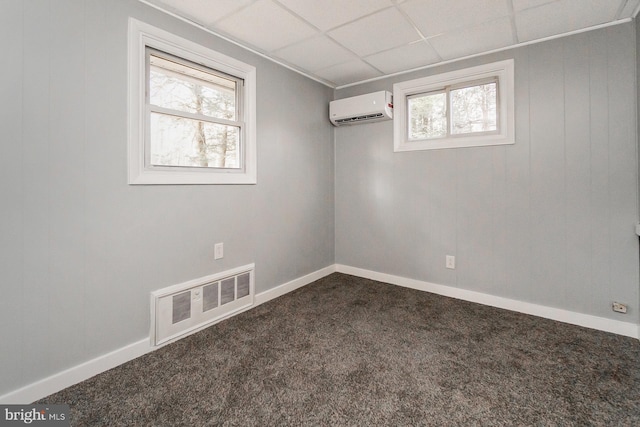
278, 0, 392, 31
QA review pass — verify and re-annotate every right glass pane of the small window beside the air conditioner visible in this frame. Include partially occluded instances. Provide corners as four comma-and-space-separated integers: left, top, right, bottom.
451, 82, 498, 134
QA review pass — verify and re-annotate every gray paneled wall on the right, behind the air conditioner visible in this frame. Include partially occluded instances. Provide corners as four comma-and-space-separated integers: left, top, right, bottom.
336, 23, 639, 322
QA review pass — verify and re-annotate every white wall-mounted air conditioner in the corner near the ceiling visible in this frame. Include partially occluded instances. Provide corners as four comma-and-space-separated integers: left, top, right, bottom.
329, 90, 393, 126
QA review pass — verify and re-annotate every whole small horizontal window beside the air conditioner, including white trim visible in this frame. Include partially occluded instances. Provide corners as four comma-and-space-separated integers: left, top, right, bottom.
393, 60, 515, 151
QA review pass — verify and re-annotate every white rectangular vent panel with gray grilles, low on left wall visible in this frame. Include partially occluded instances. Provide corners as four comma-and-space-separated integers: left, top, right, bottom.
150, 264, 254, 345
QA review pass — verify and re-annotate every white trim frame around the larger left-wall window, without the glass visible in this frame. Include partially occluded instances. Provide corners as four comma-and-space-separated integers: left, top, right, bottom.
128, 18, 257, 185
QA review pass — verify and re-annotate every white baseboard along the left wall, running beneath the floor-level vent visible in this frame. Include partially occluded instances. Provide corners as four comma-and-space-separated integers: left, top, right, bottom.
0, 265, 336, 405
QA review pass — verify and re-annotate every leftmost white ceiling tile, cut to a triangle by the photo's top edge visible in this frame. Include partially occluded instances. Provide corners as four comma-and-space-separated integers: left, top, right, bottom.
150, 0, 255, 26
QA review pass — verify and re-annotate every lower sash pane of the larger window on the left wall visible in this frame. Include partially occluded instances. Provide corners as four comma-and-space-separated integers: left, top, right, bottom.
149, 113, 240, 169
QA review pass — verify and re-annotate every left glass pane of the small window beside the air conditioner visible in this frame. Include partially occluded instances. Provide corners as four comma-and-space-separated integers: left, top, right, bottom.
408, 93, 447, 140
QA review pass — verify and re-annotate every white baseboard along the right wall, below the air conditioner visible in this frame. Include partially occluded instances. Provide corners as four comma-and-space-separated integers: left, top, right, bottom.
335, 264, 640, 339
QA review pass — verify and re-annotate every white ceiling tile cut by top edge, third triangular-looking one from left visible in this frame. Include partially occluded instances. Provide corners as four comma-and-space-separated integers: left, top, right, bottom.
401, 0, 509, 37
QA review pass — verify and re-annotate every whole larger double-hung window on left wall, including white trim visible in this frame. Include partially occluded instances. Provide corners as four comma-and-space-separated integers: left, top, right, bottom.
129, 19, 256, 184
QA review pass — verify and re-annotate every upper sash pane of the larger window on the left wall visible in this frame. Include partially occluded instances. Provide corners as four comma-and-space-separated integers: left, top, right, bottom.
149, 55, 237, 120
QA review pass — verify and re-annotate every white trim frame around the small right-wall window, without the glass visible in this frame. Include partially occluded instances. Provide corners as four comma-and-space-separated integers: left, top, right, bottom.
393, 59, 515, 152
